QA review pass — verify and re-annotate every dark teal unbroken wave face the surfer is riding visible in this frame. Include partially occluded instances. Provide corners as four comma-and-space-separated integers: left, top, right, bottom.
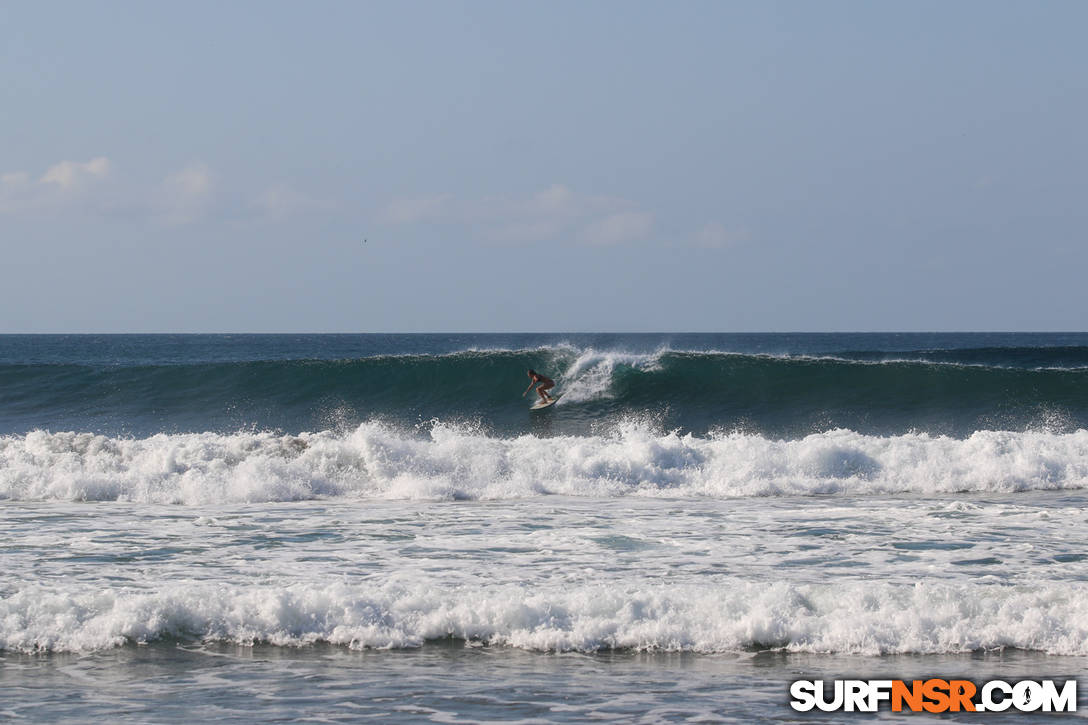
6, 341, 1088, 438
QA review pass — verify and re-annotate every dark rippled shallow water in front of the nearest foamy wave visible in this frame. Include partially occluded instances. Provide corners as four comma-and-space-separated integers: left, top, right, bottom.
0, 642, 1088, 723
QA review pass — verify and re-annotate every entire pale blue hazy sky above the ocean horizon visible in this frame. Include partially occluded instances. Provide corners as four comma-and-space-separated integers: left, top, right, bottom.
0, 1, 1088, 332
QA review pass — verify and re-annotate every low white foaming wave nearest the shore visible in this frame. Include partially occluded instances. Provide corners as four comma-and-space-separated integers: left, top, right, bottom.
8, 581, 1088, 655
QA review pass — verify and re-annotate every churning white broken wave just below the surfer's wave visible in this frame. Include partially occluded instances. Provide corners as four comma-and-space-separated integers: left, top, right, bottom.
0, 422, 1088, 505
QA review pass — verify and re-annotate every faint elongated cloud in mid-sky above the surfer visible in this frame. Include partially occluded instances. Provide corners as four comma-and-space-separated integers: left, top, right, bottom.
383, 184, 653, 244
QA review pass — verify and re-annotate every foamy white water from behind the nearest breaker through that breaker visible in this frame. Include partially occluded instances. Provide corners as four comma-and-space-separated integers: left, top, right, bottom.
6, 494, 1088, 655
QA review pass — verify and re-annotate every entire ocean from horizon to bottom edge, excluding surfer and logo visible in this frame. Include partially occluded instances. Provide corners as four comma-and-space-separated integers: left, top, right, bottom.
0, 333, 1088, 723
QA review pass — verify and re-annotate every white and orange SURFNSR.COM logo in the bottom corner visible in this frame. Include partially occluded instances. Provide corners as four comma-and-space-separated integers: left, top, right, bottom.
790, 678, 1077, 713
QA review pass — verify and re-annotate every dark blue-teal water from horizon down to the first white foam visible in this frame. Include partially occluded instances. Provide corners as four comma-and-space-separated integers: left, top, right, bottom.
0, 333, 1088, 437
